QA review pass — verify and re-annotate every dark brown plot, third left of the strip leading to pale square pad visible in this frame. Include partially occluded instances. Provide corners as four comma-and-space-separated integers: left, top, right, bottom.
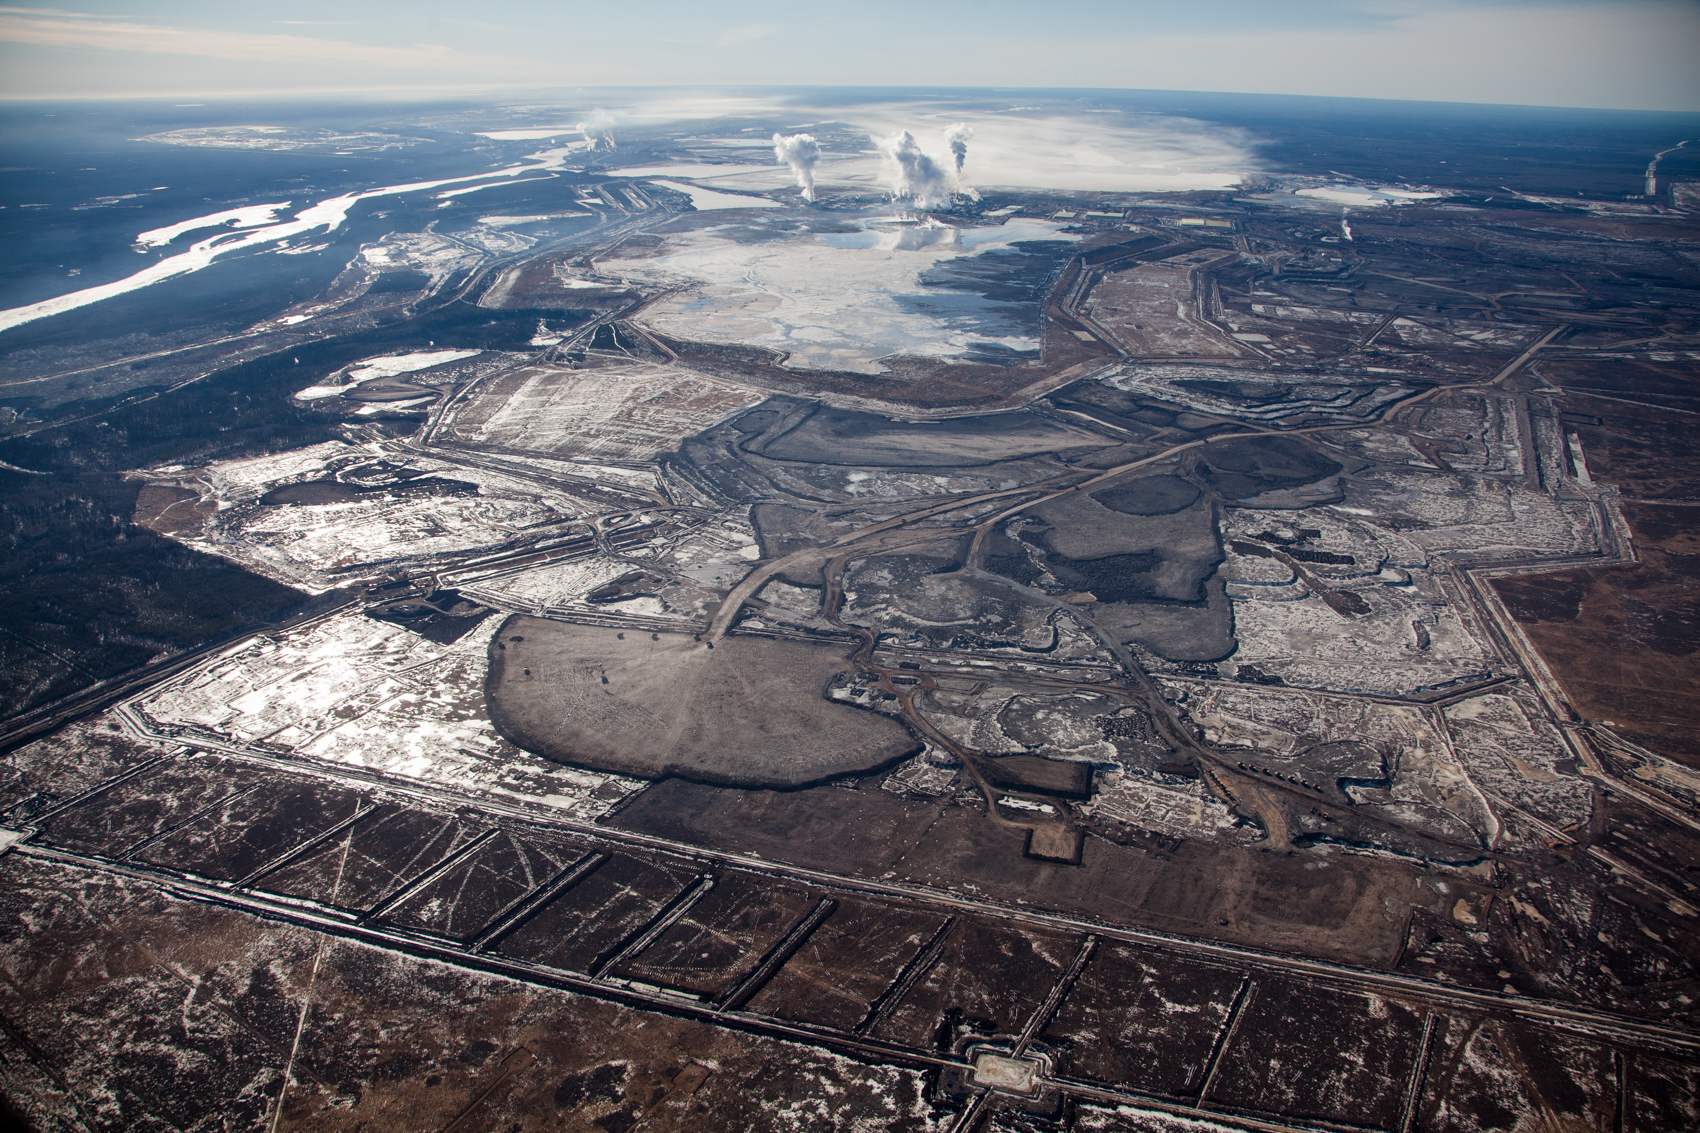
615, 874, 819, 995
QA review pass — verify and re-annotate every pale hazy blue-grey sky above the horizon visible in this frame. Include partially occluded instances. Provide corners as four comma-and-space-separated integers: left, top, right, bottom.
0, 0, 1700, 111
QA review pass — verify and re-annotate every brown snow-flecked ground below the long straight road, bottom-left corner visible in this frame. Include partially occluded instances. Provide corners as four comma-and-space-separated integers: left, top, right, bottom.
0, 856, 937, 1133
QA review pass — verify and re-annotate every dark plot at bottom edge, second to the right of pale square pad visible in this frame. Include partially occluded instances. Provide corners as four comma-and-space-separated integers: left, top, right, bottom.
1209, 978, 1423, 1130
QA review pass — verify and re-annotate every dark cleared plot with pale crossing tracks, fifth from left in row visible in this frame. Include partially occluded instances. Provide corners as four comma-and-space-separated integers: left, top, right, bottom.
384, 830, 585, 941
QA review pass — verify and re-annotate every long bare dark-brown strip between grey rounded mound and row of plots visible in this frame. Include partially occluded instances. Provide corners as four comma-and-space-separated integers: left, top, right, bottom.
612, 779, 1467, 963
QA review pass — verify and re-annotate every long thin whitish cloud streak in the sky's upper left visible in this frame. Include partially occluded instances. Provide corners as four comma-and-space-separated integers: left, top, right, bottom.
0, 9, 512, 71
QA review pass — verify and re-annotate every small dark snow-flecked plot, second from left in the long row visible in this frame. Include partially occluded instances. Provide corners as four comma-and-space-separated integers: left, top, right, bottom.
43, 760, 257, 857
